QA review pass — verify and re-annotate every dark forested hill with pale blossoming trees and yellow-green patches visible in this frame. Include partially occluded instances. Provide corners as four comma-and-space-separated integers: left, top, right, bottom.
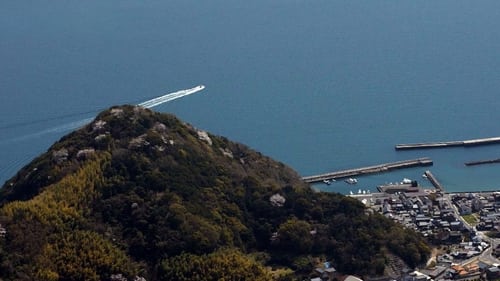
0, 106, 429, 280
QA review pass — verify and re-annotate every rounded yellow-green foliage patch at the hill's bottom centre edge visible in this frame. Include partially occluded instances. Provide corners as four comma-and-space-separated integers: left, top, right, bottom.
160, 250, 273, 281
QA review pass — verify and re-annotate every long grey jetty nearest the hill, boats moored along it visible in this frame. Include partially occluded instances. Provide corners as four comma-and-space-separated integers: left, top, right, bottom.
302, 157, 433, 183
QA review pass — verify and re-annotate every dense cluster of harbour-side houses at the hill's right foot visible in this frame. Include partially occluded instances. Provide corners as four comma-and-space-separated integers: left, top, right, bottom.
344, 178, 500, 281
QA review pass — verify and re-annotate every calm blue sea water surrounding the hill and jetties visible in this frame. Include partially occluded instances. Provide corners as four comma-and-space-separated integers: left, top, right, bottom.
0, 0, 500, 193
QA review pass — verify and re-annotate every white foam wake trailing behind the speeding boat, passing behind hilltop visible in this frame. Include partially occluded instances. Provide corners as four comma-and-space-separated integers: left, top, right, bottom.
0, 85, 205, 144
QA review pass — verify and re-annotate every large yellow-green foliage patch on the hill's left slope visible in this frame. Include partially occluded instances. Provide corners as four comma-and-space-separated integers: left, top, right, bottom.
0, 154, 137, 280
